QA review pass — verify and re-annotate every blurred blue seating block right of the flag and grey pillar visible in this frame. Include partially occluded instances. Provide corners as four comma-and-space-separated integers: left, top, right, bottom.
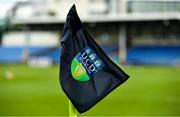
128, 46, 180, 65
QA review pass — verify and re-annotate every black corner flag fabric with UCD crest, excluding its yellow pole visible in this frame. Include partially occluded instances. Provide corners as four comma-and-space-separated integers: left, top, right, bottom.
59, 5, 129, 113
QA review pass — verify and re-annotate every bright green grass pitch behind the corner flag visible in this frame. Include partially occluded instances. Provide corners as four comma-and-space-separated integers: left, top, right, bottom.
0, 65, 180, 116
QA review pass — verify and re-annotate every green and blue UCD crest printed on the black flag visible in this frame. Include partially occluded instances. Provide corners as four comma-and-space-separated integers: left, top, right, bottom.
71, 47, 104, 81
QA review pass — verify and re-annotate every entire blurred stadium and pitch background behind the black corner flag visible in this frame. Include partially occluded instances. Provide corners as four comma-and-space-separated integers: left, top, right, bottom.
0, 0, 180, 116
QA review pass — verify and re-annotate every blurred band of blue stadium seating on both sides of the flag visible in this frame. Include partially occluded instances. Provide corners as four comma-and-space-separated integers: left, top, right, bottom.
0, 46, 180, 65
